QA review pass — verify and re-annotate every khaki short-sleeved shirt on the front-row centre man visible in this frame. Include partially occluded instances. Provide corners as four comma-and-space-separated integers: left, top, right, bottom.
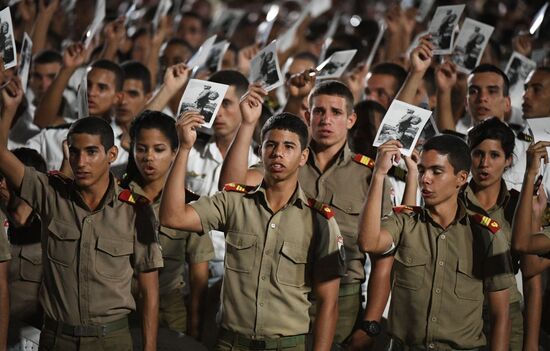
191, 185, 345, 338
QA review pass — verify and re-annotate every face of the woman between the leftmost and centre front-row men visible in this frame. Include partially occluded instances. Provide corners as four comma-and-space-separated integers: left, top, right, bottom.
134, 129, 176, 183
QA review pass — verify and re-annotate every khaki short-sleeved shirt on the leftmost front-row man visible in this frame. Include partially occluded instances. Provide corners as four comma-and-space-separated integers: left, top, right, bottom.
20, 167, 166, 325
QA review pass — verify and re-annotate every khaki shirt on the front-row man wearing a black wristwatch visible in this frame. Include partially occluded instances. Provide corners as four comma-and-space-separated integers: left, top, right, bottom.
382, 202, 515, 349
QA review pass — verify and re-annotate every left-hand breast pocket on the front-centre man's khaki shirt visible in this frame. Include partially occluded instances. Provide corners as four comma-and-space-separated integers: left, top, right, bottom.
225, 231, 258, 273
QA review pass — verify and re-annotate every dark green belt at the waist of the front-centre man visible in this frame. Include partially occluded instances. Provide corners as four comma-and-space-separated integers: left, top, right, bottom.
220, 328, 306, 350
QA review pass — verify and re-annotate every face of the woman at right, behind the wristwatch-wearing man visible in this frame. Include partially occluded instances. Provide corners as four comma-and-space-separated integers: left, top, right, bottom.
471, 139, 512, 187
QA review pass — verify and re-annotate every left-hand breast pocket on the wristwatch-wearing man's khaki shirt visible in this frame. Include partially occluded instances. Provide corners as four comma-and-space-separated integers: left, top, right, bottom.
394, 248, 430, 290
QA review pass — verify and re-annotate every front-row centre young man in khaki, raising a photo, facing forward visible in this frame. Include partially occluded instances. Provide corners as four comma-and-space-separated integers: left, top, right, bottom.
160, 97, 345, 351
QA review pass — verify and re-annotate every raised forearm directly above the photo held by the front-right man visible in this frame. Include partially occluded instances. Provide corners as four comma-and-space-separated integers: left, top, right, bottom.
397, 34, 433, 104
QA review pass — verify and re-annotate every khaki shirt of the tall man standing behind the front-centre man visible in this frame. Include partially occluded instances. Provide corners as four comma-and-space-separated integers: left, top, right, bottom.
299, 144, 392, 284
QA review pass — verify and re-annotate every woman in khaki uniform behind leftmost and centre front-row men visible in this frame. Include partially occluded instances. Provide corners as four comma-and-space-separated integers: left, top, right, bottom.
122, 111, 214, 338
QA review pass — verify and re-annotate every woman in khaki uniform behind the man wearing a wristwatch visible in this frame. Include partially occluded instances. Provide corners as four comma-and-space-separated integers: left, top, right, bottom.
464, 118, 527, 350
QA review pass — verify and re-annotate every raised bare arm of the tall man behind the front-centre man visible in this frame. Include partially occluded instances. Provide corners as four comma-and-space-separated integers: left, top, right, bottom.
218, 84, 267, 190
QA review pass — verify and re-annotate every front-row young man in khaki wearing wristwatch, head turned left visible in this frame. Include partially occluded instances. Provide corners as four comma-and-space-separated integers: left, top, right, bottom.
359, 135, 515, 350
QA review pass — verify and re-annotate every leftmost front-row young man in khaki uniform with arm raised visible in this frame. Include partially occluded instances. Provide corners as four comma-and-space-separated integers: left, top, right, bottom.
0, 87, 162, 350
